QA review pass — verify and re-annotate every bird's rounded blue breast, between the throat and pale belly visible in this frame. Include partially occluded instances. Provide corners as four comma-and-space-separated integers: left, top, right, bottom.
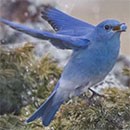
63, 39, 119, 80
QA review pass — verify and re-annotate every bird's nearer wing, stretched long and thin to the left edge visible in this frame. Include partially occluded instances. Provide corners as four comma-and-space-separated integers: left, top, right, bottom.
0, 18, 90, 49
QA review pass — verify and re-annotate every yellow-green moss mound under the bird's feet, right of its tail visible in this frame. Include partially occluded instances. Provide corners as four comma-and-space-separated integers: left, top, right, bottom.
52, 88, 130, 130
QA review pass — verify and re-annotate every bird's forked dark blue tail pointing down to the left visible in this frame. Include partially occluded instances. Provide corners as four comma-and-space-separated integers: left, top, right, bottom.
26, 91, 63, 126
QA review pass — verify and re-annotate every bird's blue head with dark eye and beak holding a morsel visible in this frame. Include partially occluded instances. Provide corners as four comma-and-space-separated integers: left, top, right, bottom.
96, 19, 127, 40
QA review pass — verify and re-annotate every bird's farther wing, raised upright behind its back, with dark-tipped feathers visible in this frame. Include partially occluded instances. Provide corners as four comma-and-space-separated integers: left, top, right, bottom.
42, 6, 95, 31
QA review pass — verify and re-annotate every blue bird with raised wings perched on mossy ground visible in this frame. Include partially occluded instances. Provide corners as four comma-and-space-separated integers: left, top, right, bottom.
0, 6, 127, 126
